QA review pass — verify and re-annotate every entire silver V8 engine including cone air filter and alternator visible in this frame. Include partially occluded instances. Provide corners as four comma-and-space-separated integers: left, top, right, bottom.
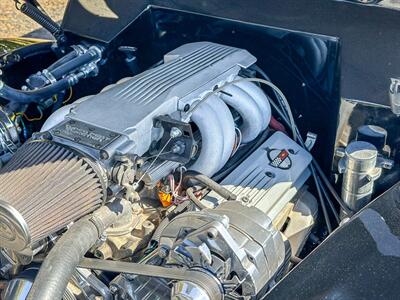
0, 42, 317, 299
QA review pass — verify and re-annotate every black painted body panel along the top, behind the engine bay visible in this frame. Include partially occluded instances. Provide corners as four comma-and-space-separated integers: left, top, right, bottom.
63, 0, 400, 104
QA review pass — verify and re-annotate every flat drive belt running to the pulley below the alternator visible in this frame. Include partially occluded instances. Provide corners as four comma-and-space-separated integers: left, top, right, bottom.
78, 258, 223, 300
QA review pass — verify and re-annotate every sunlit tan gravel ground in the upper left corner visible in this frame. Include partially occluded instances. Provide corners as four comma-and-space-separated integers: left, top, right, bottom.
0, 0, 67, 38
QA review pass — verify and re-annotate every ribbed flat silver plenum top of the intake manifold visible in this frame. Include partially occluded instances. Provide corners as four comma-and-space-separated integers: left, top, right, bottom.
67, 42, 256, 155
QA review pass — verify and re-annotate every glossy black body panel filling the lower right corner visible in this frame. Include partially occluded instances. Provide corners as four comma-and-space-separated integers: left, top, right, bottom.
266, 183, 400, 300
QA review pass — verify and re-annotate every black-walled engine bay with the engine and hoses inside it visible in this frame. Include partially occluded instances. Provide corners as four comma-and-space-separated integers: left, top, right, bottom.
0, 3, 399, 300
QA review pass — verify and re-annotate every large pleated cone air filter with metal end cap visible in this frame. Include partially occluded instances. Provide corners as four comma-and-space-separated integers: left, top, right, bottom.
0, 140, 104, 252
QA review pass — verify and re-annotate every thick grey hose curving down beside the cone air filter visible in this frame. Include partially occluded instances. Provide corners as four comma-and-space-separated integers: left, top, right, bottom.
27, 200, 129, 300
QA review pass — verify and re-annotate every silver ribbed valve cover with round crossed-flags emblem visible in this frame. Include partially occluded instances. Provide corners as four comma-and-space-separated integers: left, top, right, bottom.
202, 132, 312, 220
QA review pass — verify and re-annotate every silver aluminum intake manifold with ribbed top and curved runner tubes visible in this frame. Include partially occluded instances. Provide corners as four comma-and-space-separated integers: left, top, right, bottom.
42, 42, 271, 175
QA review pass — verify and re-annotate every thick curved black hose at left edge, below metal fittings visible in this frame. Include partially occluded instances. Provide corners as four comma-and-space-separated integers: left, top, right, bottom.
0, 77, 73, 104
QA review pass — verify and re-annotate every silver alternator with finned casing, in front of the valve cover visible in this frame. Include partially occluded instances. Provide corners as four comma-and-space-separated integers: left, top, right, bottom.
160, 201, 289, 299
